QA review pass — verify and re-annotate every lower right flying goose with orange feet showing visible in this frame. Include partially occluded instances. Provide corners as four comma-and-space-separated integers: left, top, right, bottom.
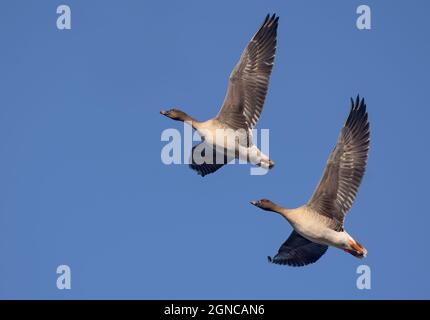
251, 96, 370, 266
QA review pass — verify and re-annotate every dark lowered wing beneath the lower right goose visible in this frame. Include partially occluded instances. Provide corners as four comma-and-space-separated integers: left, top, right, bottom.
268, 231, 328, 267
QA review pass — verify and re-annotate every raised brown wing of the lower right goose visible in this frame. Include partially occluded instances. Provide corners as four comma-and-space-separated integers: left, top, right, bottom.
308, 96, 370, 231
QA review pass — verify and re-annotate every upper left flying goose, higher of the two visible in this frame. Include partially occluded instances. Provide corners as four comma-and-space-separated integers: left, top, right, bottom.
160, 14, 279, 176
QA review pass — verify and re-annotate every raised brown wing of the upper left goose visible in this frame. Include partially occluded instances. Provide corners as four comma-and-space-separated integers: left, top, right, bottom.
217, 14, 279, 130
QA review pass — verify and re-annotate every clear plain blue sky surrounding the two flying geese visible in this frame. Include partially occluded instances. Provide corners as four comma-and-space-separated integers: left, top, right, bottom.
0, 0, 430, 299
